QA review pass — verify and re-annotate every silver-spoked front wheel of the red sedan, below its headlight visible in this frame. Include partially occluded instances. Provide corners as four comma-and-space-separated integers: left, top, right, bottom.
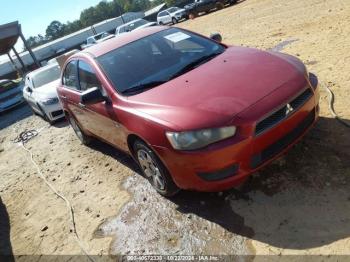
133, 140, 180, 197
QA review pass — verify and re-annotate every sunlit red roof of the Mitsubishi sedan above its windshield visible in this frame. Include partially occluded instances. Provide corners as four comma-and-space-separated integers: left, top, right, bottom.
80, 26, 169, 57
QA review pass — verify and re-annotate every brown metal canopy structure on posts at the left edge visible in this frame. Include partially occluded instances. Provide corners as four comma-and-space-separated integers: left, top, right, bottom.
0, 21, 40, 73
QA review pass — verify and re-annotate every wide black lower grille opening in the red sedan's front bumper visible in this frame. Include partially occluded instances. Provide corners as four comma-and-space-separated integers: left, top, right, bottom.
250, 110, 315, 169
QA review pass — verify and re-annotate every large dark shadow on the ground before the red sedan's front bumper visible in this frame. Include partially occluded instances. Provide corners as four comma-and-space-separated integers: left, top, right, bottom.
170, 117, 350, 249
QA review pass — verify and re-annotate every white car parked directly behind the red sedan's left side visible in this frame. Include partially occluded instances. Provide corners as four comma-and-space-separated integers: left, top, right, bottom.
23, 64, 64, 123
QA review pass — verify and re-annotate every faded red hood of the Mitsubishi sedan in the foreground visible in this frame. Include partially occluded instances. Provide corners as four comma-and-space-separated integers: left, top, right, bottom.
128, 47, 305, 129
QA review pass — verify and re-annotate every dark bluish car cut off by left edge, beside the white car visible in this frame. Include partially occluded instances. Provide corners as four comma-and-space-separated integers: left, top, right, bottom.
0, 79, 24, 113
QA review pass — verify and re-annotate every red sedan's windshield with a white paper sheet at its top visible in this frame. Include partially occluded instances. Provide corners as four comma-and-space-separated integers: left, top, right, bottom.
97, 28, 225, 93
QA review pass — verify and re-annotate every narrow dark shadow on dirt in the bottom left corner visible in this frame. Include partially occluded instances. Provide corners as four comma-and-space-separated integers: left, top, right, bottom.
0, 197, 14, 261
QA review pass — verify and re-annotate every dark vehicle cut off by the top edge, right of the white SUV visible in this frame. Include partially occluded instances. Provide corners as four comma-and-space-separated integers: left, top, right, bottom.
185, 0, 237, 18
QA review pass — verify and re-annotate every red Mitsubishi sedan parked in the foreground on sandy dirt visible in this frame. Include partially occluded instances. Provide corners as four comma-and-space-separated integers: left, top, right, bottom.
58, 27, 319, 196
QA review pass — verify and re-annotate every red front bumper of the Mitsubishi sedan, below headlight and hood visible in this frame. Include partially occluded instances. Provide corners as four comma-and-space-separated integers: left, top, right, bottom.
155, 81, 319, 191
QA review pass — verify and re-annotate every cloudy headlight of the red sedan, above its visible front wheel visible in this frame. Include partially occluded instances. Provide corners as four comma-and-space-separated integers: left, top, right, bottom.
166, 126, 236, 150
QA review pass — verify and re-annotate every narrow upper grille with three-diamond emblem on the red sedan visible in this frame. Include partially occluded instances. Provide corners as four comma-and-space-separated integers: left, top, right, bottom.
255, 88, 312, 135
